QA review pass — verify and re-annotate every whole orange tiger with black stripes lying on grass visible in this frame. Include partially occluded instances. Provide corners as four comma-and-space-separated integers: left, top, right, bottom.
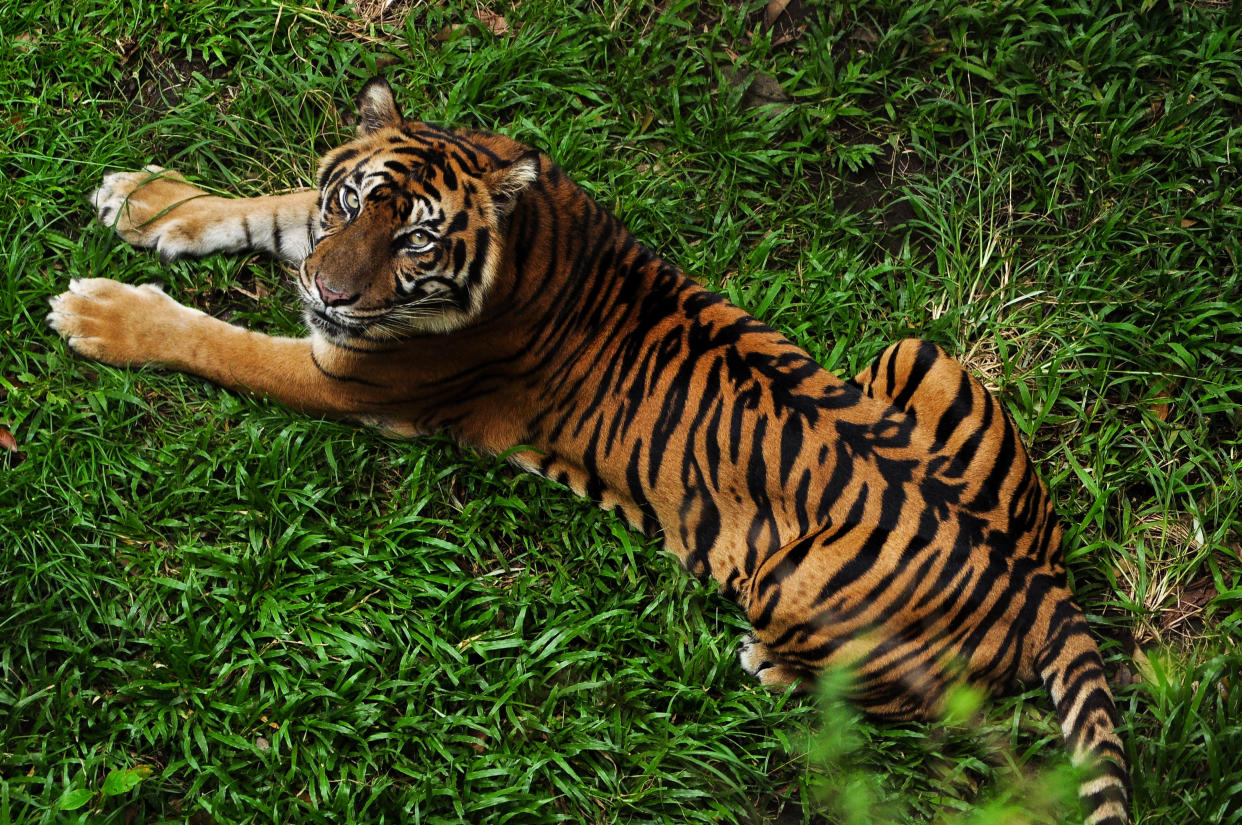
48, 78, 1129, 825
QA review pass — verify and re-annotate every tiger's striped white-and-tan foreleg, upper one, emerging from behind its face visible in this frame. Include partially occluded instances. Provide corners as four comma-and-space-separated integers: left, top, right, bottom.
91, 166, 319, 263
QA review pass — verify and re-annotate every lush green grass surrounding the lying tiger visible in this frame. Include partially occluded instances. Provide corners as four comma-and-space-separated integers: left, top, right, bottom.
0, 0, 1242, 825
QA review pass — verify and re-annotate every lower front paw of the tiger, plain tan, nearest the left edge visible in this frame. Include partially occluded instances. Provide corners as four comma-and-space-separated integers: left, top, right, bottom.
47, 278, 206, 367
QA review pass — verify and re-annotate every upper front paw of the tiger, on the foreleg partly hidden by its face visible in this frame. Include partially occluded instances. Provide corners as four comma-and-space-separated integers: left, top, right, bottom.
91, 165, 221, 263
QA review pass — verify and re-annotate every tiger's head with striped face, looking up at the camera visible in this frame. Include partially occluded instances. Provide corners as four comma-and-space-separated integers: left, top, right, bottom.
298, 78, 540, 340
